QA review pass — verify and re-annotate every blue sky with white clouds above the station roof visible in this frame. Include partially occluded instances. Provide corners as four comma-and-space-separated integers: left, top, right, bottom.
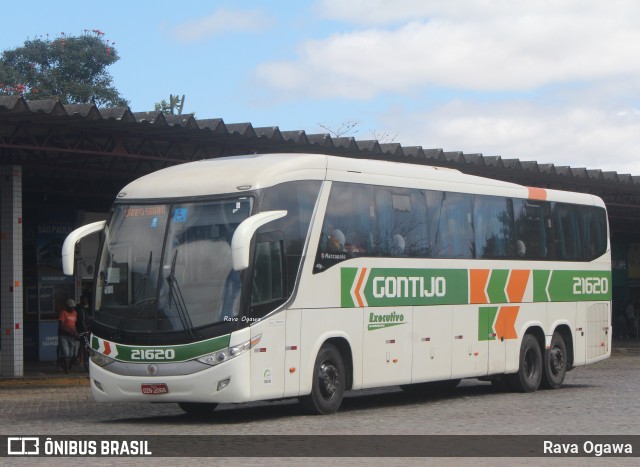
0, 0, 640, 175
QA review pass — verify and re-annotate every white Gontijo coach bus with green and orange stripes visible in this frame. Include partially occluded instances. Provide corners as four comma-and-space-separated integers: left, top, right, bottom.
63, 154, 611, 414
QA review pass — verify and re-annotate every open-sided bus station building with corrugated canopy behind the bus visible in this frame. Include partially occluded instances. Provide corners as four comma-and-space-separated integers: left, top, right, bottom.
0, 96, 640, 377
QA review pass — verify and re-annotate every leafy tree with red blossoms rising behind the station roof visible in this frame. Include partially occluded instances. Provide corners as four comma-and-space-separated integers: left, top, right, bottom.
0, 29, 128, 106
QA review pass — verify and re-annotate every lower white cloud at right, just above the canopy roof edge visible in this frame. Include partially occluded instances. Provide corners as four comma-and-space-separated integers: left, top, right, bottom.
392, 101, 640, 174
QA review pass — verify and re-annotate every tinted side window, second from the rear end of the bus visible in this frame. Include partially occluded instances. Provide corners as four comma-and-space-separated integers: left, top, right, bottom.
551, 203, 583, 261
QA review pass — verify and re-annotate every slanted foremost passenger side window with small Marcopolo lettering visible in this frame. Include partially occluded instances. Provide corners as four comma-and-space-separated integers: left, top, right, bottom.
314, 182, 378, 273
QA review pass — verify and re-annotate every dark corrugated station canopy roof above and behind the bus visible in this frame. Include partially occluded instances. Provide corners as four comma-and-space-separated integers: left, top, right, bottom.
0, 96, 640, 237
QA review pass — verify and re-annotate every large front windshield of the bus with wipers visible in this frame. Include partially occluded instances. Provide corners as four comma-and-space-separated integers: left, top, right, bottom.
94, 197, 253, 338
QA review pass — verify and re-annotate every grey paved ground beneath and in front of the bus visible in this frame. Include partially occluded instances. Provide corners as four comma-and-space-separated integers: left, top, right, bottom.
0, 353, 640, 465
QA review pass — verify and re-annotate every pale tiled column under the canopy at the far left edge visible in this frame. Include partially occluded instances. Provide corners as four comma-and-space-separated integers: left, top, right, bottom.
0, 166, 24, 377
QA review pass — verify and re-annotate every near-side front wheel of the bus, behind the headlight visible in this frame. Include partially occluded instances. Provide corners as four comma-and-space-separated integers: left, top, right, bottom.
300, 344, 347, 415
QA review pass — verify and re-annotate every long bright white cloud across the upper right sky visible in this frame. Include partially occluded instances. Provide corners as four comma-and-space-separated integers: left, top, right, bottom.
257, 0, 640, 99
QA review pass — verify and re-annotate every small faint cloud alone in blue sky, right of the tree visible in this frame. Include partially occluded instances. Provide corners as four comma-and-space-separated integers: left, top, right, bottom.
172, 8, 272, 42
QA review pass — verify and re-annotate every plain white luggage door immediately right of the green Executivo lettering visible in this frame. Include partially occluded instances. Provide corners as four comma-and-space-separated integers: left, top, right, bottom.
411, 305, 453, 383
